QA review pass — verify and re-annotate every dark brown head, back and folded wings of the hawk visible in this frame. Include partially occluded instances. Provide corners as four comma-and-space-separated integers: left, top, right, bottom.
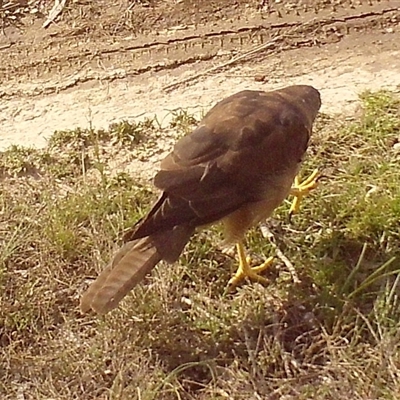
131, 86, 320, 238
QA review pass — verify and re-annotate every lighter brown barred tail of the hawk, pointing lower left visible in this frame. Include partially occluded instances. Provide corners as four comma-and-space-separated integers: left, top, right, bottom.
80, 228, 193, 314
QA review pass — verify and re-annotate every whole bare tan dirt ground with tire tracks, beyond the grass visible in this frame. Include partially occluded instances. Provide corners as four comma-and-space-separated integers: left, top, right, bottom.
0, 0, 400, 149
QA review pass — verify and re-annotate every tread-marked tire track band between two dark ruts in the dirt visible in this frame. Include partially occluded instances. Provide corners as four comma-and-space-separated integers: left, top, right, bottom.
0, 2, 400, 98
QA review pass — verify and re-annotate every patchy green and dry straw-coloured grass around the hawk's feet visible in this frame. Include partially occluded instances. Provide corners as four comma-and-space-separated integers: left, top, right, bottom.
0, 92, 400, 400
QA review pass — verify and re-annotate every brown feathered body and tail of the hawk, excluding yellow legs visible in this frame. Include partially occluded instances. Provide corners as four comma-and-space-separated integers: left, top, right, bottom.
81, 85, 321, 314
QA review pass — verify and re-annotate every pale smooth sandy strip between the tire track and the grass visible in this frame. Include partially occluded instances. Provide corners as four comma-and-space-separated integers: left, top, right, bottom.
0, 31, 400, 149
